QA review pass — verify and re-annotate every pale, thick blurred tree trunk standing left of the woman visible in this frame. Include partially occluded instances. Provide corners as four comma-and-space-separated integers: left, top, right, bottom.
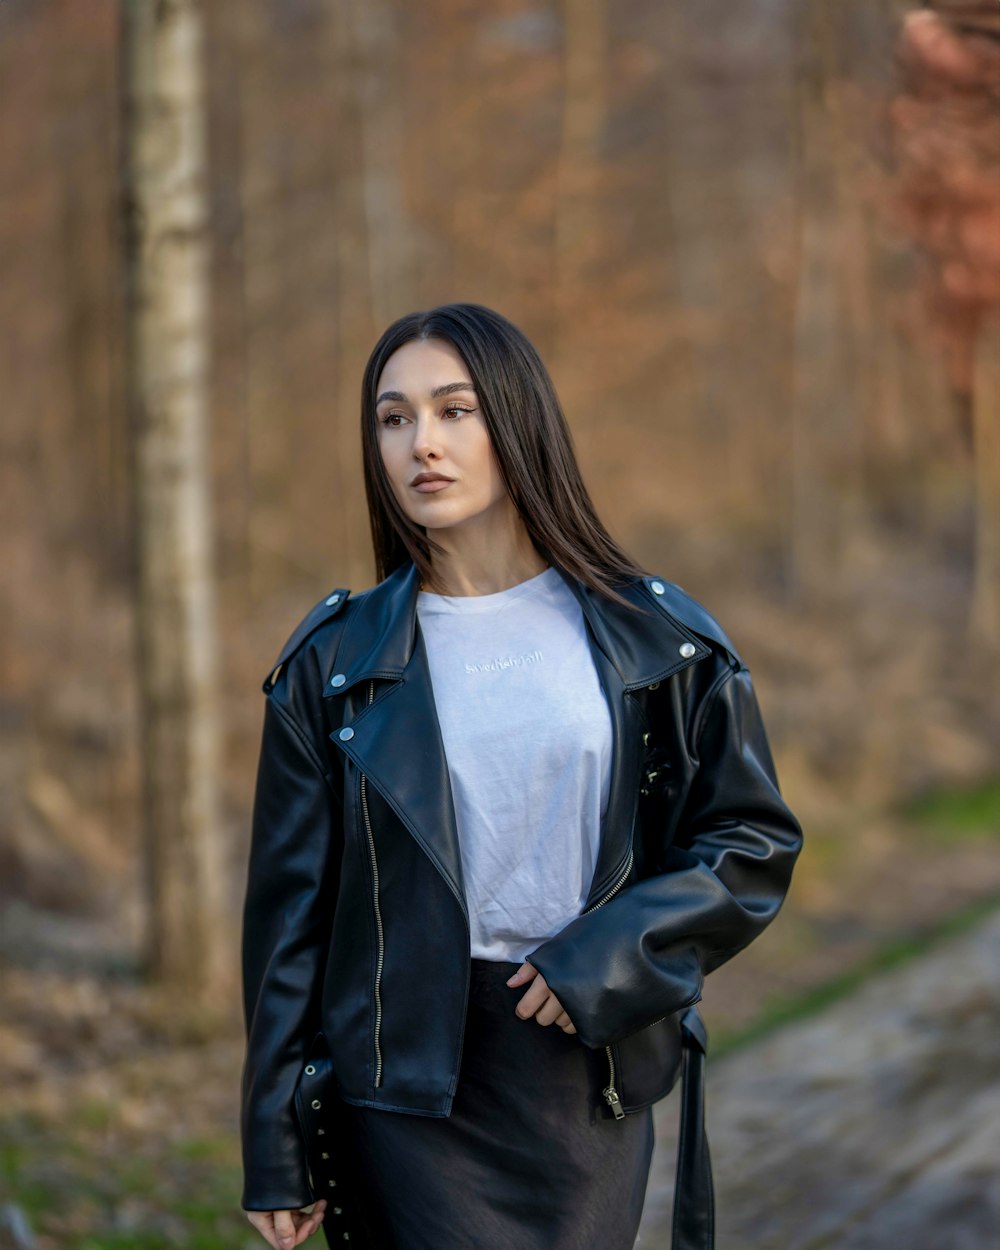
120, 0, 225, 1005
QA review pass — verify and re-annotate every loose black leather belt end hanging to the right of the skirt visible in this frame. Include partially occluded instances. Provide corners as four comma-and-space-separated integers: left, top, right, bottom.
671, 1006, 715, 1250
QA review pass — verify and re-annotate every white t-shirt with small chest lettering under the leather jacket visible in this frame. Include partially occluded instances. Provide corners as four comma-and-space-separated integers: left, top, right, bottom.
416, 569, 611, 961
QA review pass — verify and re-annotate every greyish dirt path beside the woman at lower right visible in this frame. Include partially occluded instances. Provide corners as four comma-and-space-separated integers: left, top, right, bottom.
638, 913, 1000, 1250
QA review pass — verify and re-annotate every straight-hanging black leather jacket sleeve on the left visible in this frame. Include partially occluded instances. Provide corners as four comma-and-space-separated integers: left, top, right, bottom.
240, 694, 341, 1211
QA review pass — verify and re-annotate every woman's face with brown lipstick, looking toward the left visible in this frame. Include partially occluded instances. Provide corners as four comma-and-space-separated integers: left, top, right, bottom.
375, 339, 515, 534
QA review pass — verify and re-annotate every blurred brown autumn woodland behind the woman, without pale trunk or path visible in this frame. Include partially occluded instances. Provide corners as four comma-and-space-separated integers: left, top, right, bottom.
0, 0, 1000, 1250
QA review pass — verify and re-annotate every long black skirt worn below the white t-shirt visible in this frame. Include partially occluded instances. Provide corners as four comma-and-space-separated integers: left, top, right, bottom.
324, 960, 653, 1250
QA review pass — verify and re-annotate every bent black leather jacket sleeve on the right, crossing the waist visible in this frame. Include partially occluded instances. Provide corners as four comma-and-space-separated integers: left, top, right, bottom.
529, 666, 803, 1046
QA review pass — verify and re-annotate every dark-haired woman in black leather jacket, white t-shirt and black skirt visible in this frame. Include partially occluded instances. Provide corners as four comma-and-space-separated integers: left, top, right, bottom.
241, 304, 801, 1250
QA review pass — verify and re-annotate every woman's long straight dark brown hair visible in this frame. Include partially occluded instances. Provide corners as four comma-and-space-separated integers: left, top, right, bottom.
361, 304, 643, 603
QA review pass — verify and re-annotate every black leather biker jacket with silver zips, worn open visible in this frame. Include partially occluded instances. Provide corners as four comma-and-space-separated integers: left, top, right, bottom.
241, 565, 801, 1210
